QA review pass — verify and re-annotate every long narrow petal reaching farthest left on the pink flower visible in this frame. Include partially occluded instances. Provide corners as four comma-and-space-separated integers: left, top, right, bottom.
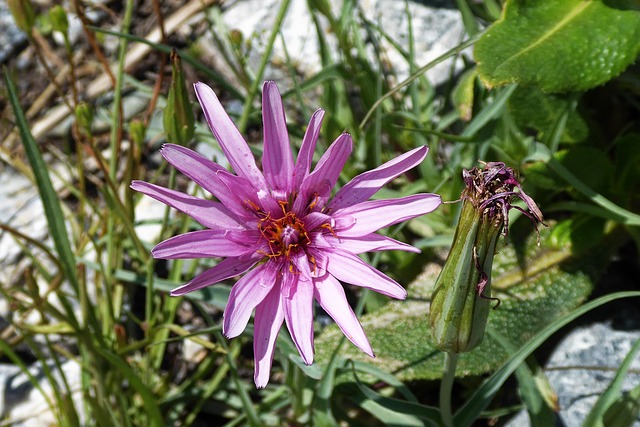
131, 181, 242, 230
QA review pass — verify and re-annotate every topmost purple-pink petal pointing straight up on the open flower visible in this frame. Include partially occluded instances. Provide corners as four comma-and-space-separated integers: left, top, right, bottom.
262, 81, 293, 192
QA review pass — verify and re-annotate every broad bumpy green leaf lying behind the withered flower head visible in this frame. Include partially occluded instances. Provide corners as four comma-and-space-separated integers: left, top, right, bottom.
316, 224, 615, 381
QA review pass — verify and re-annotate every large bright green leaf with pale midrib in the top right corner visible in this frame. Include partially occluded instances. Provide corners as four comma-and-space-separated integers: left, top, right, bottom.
474, 0, 640, 92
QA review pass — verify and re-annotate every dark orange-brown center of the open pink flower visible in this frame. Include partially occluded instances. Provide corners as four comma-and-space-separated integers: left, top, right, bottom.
258, 206, 310, 258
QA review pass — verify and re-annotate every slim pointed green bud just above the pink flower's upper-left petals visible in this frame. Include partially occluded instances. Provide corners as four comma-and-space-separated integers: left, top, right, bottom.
162, 50, 195, 145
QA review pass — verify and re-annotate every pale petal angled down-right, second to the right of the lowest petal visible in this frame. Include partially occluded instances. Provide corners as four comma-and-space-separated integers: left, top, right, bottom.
314, 274, 375, 357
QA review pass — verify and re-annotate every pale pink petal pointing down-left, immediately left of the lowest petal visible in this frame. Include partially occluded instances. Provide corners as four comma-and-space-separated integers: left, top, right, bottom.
222, 262, 279, 338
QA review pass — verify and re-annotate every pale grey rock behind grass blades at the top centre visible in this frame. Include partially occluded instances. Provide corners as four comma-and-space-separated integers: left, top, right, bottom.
200, 0, 466, 93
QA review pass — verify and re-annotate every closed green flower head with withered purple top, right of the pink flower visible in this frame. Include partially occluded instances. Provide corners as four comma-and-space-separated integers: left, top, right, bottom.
429, 162, 543, 353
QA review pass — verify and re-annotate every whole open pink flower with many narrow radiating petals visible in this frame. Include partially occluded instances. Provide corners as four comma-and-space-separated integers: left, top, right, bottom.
131, 82, 441, 387
